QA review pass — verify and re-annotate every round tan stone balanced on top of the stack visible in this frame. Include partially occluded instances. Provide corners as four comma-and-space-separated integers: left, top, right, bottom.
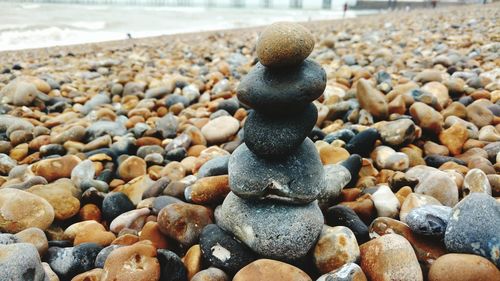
257, 22, 314, 67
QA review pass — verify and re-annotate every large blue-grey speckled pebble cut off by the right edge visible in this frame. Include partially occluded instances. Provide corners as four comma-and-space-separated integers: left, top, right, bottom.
444, 193, 500, 267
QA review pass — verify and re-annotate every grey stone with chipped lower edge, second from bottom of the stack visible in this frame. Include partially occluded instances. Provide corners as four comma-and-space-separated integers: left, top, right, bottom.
229, 139, 324, 203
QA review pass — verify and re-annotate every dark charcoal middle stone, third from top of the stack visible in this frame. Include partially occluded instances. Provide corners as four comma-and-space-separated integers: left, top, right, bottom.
244, 103, 318, 158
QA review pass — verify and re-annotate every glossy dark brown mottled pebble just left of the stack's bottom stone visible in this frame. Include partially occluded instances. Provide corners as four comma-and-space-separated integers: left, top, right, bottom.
158, 203, 213, 246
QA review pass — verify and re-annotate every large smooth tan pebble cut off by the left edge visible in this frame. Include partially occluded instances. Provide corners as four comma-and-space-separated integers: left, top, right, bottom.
0, 188, 54, 233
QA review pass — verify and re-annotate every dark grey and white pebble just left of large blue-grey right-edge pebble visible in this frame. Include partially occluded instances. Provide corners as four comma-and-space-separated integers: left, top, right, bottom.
406, 205, 451, 237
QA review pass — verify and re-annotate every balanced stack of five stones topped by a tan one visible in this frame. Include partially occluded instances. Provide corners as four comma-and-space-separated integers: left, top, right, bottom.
215, 23, 326, 260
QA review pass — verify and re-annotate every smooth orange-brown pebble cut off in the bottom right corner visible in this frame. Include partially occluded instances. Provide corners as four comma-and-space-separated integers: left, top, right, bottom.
429, 254, 500, 281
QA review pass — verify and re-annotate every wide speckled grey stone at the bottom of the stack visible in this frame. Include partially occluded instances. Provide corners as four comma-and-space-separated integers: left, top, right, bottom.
215, 192, 323, 260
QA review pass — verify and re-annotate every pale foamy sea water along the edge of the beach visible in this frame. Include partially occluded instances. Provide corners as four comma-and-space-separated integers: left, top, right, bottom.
0, 1, 376, 51
